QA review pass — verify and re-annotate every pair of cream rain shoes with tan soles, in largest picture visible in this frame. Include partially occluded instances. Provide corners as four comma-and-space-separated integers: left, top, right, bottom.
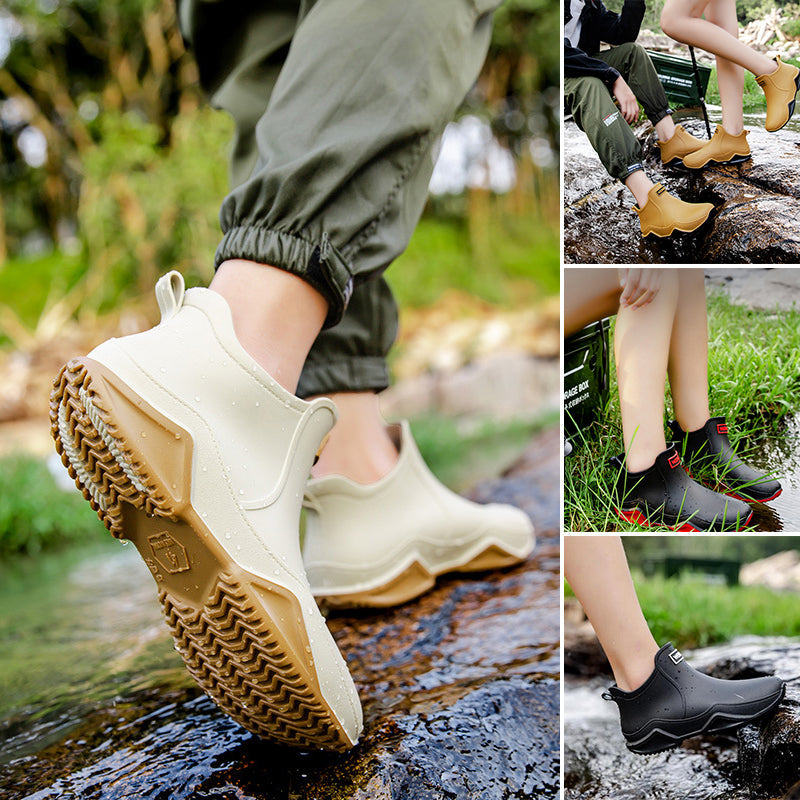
51, 272, 534, 750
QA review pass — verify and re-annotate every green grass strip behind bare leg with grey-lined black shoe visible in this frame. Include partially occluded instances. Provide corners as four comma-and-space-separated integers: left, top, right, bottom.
564, 571, 800, 648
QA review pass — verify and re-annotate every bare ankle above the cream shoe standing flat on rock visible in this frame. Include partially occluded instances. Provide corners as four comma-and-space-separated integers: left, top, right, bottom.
309, 392, 397, 484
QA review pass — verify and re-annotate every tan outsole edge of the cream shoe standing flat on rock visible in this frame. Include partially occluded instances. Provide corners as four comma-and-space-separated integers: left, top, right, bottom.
316, 544, 525, 608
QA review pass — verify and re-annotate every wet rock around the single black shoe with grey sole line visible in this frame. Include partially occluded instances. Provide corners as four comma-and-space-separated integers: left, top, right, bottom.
564, 637, 800, 800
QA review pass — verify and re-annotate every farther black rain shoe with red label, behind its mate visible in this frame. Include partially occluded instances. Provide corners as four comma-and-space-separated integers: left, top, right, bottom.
670, 417, 783, 503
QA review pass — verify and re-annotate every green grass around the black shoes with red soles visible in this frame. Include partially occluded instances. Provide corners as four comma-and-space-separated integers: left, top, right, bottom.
564, 294, 800, 531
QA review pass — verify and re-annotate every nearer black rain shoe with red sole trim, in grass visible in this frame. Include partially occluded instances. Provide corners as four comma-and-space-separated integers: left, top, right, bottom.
611, 445, 753, 532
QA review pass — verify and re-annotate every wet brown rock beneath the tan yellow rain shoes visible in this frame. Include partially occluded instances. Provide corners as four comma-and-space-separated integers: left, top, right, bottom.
564, 113, 800, 264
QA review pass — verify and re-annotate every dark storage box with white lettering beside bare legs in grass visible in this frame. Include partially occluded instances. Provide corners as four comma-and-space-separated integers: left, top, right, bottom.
564, 319, 611, 434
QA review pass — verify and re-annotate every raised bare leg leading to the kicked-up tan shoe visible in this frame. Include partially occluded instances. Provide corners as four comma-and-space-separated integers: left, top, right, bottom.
661, 0, 777, 78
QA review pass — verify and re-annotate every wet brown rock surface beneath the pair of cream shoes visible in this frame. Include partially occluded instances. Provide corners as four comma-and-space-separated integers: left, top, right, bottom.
0, 430, 560, 800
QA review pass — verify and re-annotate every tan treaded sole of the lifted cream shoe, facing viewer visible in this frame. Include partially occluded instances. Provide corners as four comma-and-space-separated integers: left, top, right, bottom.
50, 358, 353, 750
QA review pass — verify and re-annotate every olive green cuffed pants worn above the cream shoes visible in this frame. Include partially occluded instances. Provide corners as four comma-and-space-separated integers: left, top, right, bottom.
180, 0, 499, 397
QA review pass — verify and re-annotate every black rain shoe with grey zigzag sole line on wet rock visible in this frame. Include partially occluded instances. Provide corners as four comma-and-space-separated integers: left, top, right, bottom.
603, 643, 786, 754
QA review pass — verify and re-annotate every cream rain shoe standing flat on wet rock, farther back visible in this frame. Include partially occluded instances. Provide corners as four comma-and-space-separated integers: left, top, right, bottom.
303, 422, 534, 607
